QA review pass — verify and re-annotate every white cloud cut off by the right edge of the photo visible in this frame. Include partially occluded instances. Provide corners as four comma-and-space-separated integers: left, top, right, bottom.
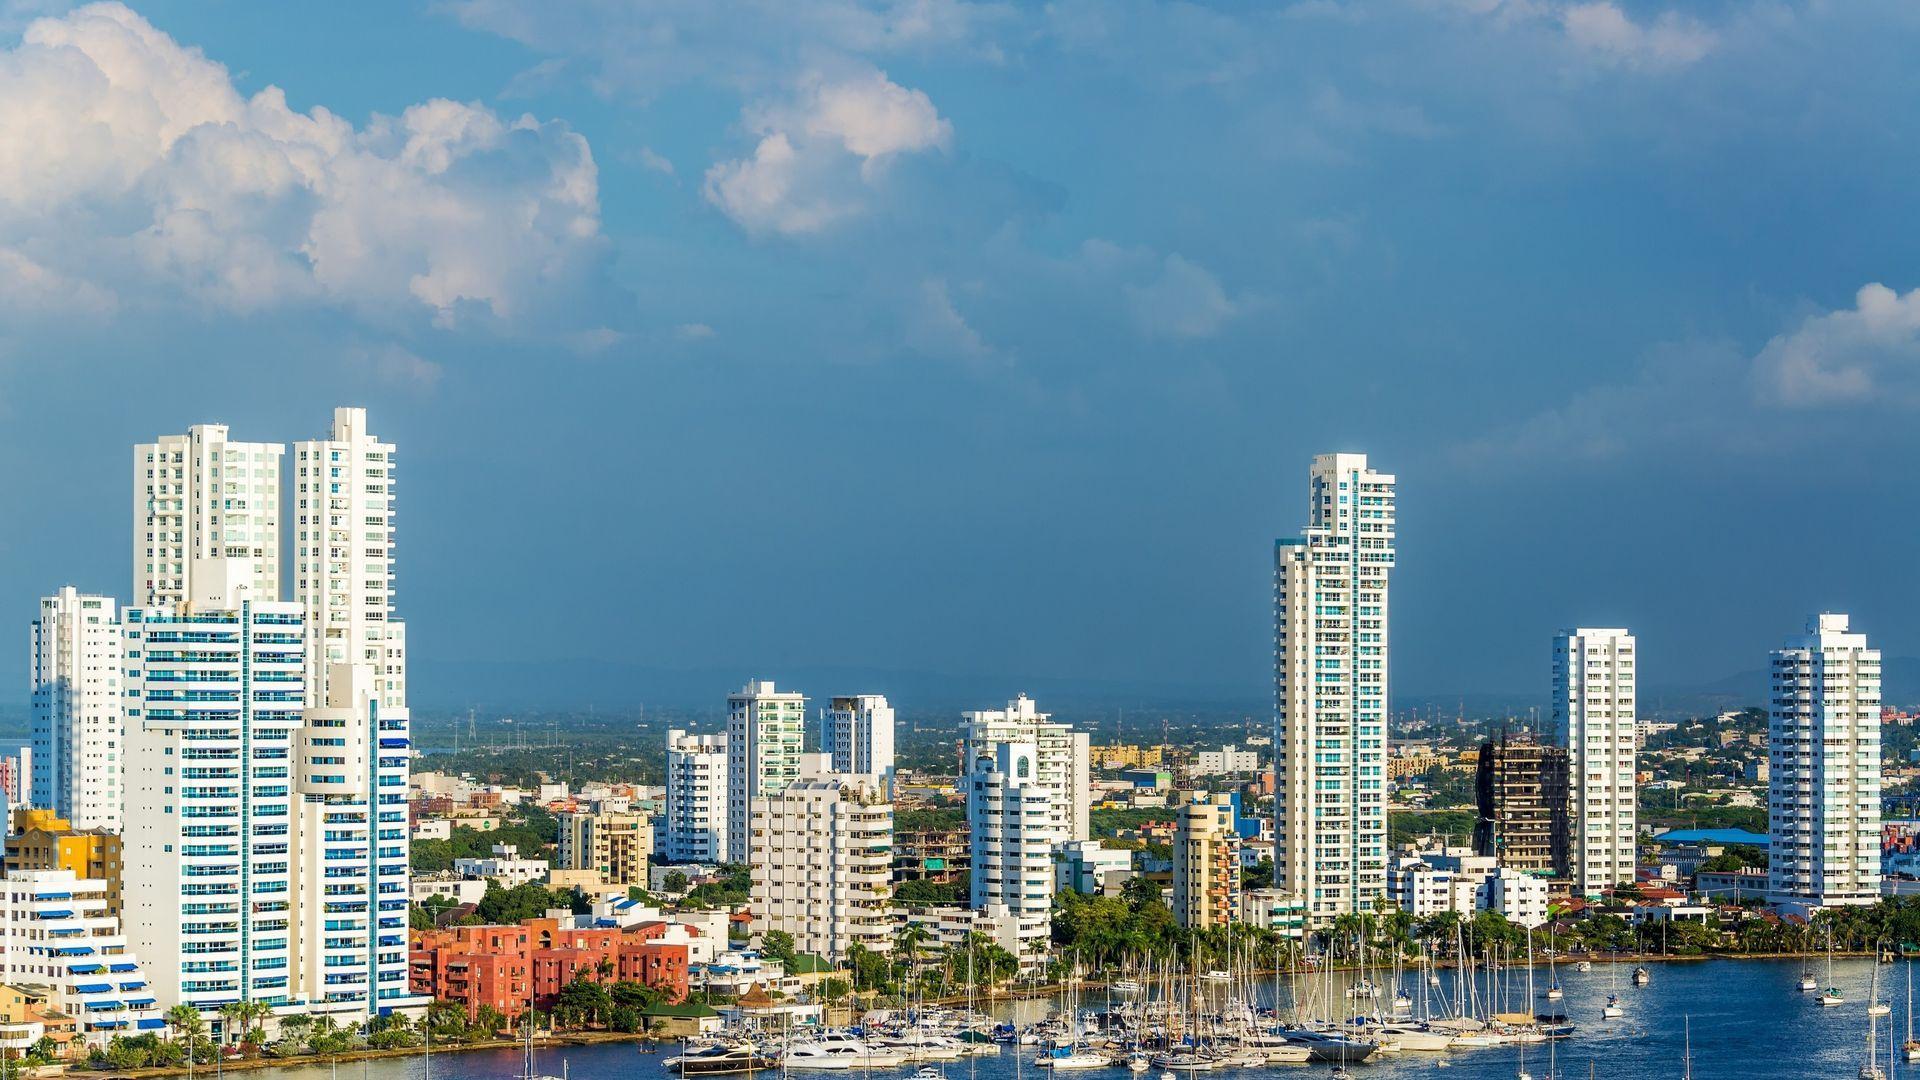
1753, 282, 1920, 409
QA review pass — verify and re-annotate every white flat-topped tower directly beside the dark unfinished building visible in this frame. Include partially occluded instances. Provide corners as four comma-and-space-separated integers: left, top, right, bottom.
1553, 628, 1640, 896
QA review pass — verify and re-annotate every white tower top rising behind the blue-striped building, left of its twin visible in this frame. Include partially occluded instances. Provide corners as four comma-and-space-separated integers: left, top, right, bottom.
132, 425, 286, 607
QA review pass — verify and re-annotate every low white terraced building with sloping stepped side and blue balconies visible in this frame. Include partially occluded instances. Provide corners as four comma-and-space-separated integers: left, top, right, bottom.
0, 871, 167, 1045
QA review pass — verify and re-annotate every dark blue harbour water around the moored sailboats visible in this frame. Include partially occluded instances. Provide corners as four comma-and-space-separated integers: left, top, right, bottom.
246, 959, 1920, 1080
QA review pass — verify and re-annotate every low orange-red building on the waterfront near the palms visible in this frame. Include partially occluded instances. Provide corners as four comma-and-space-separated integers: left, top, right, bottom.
409, 919, 687, 1017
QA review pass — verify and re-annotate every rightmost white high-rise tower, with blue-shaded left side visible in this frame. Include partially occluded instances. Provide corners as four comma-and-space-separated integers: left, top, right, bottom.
1766, 615, 1880, 913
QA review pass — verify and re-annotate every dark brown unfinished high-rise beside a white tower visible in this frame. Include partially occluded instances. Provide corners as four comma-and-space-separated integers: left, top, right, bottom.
1473, 730, 1571, 878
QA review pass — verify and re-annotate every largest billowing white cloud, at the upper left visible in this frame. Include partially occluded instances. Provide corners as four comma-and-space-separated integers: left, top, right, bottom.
0, 4, 599, 325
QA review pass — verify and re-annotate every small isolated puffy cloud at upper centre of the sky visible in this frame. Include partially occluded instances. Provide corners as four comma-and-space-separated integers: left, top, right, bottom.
703, 71, 952, 236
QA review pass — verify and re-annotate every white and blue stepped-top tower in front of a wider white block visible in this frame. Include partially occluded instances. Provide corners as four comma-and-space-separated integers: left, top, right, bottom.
966, 740, 1060, 967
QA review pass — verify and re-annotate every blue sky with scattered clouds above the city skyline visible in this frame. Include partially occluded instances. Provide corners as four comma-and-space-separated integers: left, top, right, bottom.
0, 0, 1920, 705
